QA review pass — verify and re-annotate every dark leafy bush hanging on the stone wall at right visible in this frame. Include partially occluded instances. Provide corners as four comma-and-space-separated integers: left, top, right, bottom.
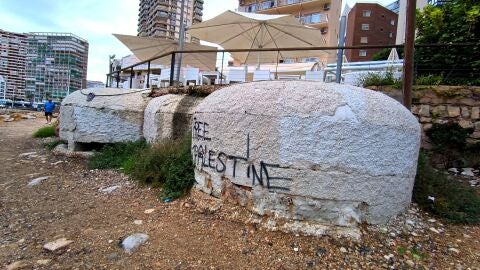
425, 123, 473, 167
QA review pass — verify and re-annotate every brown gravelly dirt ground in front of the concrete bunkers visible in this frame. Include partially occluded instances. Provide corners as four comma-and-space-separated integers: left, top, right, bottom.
0, 119, 480, 269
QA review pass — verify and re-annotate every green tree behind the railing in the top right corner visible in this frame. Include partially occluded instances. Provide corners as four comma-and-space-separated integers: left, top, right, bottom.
415, 0, 480, 84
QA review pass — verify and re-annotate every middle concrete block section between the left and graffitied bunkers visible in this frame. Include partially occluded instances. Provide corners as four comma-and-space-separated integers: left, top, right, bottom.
143, 94, 203, 143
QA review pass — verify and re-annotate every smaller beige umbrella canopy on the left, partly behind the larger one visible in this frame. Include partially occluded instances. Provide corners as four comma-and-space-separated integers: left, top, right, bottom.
113, 34, 217, 70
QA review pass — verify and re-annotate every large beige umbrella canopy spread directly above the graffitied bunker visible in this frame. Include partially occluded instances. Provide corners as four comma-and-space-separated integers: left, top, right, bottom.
188, 10, 326, 64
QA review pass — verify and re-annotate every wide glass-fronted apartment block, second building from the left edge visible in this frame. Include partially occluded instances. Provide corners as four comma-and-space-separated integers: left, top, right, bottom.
26, 32, 88, 102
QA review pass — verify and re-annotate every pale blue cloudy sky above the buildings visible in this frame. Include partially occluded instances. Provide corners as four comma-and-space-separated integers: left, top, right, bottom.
0, 0, 393, 81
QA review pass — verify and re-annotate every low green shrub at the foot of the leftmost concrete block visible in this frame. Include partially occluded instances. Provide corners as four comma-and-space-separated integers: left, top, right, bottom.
88, 139, 147, 169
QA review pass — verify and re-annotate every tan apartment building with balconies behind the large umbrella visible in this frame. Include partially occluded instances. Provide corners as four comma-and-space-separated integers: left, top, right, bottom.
238, 0, 342, 63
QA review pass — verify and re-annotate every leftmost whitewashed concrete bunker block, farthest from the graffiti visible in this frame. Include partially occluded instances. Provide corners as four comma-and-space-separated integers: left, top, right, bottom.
60, 88, 149, 150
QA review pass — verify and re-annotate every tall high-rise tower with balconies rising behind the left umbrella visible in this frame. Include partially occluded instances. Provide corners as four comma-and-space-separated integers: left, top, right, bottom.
138, 0, 203, 43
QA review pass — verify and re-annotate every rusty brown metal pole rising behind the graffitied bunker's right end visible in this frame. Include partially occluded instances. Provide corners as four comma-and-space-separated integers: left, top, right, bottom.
402, 0, 416, 110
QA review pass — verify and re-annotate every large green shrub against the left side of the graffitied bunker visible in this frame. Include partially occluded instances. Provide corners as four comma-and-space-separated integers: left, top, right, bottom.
123, 137, 194, 199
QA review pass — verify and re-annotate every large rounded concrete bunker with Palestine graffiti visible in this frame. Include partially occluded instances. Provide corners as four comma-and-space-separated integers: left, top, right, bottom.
192, 81, 420, 231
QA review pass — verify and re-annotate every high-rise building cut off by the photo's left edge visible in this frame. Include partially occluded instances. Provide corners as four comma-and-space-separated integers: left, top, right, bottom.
0, 29, 27, 100
